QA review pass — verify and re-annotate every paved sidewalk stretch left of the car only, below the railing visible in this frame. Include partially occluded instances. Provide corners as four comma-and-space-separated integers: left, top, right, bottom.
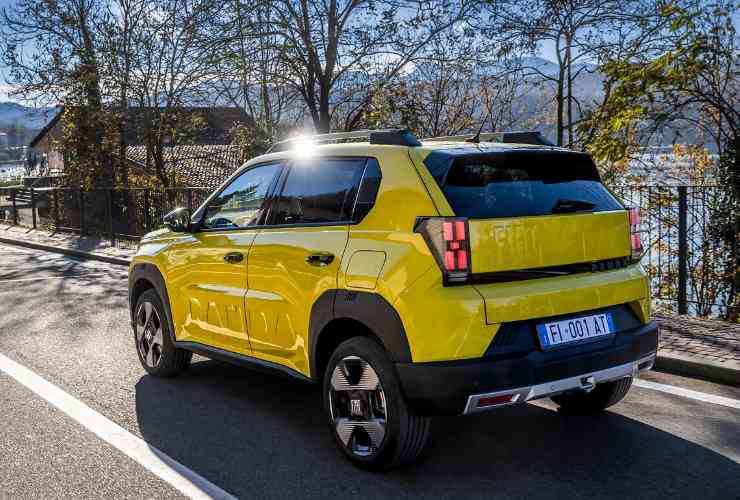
0, 223, 136, 266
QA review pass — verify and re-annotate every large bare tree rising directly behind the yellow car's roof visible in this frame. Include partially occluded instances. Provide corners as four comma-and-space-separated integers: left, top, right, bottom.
249, 0, 473, 132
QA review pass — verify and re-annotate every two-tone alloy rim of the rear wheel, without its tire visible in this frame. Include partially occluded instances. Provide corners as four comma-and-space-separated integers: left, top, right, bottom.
329, 356, 388, 457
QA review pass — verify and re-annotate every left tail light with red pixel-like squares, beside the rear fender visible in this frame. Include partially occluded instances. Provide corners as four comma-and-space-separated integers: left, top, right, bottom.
415, 217, 470, 285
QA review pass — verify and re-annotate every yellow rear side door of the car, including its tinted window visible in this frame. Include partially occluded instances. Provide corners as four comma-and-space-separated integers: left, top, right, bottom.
246, 158, 366, 375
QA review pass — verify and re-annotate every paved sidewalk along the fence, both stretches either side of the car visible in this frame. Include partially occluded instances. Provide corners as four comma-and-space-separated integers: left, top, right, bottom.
0, 223, 740, 386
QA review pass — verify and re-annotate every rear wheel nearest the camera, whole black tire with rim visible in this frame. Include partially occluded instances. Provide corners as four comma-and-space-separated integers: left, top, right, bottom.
322, 337, 430, 470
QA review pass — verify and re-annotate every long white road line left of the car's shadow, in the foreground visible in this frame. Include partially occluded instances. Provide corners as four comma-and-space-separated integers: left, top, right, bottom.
0, 354, 236, 500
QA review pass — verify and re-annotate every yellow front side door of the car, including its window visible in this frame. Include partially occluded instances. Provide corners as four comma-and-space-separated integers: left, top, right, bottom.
169, 163, 282, 354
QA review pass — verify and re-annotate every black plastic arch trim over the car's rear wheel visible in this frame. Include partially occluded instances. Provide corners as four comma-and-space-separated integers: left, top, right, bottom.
309, 289, 411, 380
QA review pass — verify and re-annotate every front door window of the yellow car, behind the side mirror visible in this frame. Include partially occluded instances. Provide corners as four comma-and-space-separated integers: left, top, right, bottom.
203, 163, 281, 229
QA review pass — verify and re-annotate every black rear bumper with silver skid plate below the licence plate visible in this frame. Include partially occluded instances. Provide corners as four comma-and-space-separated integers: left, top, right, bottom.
396, 322, 658, 415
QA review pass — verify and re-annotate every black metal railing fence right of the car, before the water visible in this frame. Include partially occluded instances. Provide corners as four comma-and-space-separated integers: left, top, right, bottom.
613, 185, 738, 318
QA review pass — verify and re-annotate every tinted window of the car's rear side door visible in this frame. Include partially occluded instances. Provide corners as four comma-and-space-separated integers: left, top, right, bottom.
270, 158, 366, 224
